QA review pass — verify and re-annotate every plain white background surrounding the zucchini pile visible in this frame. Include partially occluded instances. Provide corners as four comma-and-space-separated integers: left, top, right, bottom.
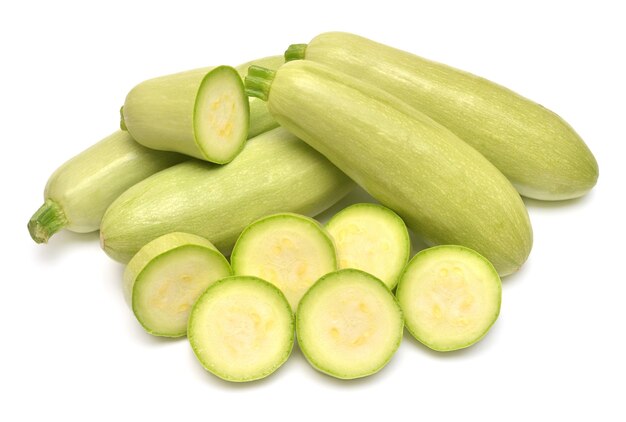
0, 0, 626, 421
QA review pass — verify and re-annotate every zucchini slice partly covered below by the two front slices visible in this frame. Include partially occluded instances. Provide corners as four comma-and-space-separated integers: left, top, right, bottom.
230, 213, 337, 311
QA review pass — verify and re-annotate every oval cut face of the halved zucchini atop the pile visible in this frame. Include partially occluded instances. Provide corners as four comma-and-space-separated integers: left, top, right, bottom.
194, 66, 250, 164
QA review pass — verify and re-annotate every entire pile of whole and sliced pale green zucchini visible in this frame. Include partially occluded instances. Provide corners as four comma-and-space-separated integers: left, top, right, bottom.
28, 33, 598, 381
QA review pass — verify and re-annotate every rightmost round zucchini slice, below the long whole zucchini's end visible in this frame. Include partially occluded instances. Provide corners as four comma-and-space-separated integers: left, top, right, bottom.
396, 245, 502, 352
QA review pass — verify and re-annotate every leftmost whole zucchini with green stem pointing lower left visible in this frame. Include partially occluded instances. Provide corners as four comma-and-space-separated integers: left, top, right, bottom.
28, 130, 187, 243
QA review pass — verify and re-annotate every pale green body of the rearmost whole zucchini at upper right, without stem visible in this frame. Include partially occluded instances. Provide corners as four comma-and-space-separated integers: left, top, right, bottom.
305, 32, 598, 200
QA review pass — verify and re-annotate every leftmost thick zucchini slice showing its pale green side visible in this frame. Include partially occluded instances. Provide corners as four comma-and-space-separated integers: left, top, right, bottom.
124, 233, 231, 337
